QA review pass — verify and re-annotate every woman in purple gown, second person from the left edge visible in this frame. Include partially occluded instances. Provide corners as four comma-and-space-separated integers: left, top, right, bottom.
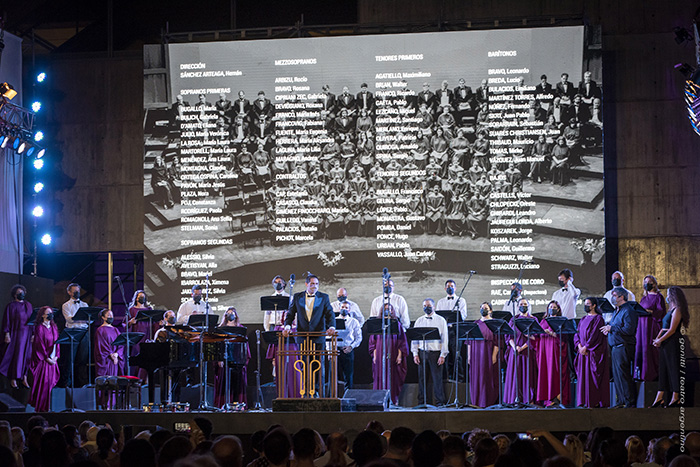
29, 306, 61, 412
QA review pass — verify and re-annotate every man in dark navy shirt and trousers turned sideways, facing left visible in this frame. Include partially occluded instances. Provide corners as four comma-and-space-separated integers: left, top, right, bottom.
600, 287, 639, 407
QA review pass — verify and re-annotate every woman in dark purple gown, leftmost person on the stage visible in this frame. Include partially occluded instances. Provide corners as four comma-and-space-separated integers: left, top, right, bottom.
0, 284, 32, 388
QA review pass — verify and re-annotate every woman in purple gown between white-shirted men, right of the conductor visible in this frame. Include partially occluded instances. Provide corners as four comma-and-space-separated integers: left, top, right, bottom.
369, 303, 408, 405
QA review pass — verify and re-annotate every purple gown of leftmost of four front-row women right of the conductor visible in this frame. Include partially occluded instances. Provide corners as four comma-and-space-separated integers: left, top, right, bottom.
469, 320, 498, 407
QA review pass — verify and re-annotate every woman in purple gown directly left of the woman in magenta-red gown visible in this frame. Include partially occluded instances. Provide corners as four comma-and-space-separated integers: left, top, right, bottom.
503, 298, 537, 404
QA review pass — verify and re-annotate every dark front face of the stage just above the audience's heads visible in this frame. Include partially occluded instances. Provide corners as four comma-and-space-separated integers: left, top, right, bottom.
2, 407, 700, 437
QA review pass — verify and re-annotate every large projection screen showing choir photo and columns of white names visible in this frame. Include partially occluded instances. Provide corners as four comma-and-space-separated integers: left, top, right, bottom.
144, 27, 605, 323
